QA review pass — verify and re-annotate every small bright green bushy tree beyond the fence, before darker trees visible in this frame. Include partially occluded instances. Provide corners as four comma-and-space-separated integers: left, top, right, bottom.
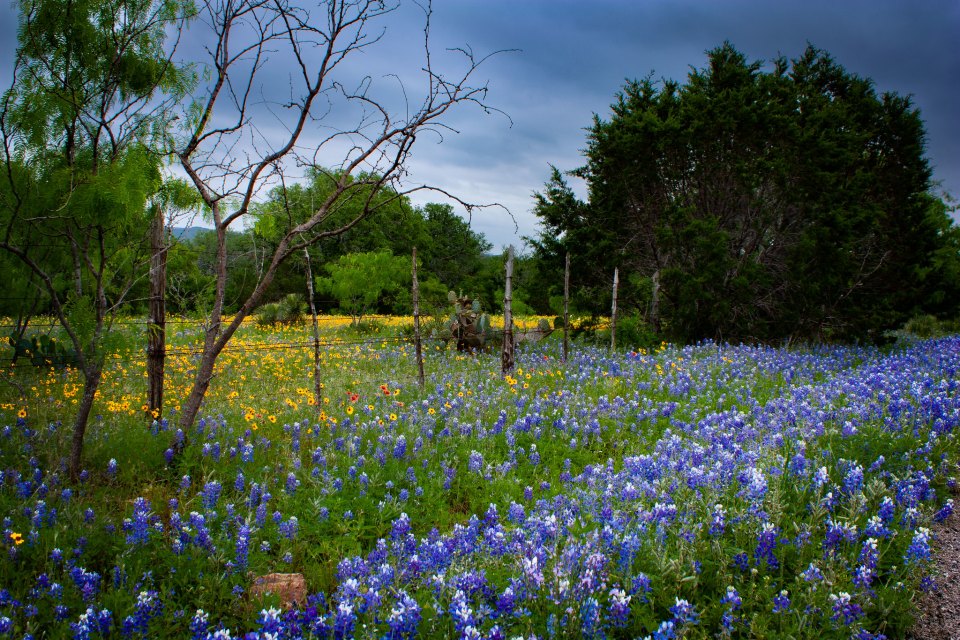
317, 251, 411, 326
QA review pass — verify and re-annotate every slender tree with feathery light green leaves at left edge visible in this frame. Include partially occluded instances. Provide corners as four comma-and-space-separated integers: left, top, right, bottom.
0, 0, 192, 475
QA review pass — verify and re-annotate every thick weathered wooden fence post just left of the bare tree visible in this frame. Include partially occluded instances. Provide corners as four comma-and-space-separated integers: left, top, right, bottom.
147, 207, 167, 417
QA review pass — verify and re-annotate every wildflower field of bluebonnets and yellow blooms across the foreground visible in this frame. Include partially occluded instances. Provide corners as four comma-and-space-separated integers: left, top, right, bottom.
0, 319, 960, 639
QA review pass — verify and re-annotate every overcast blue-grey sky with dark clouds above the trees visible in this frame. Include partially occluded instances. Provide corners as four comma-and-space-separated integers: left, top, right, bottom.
0, 0, 960, 248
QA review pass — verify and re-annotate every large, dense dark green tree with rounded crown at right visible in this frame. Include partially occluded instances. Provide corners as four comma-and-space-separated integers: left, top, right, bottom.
535, 43, 957, 341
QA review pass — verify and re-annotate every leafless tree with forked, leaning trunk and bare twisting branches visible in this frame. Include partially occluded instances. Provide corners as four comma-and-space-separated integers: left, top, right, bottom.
176, 0, 510, 431
